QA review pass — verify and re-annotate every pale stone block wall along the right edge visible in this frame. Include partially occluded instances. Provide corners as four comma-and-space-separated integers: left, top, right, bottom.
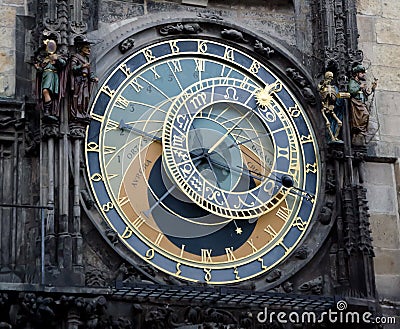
357, 0, 400, 322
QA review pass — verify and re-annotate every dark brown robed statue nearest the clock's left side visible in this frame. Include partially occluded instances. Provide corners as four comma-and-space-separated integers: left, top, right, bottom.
70, 39, 99, 121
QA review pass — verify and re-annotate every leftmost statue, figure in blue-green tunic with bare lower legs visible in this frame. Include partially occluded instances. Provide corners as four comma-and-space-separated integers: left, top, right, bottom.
34, 40, 67, 121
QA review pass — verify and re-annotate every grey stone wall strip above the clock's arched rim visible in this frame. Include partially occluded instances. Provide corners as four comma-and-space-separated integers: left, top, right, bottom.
99, 0, 296, 49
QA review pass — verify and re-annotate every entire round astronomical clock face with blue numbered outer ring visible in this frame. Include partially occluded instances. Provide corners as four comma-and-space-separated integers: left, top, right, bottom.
85, 39, 320, 284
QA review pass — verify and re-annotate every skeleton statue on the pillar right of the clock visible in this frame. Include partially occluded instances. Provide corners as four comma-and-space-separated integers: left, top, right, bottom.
318, 71, 343, 142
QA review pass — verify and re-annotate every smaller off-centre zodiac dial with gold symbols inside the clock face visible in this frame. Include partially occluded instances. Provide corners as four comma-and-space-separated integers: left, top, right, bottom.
162, 78, 293, 219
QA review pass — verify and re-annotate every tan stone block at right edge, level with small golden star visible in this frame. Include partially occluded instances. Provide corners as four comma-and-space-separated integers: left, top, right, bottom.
370, 214, 400, 247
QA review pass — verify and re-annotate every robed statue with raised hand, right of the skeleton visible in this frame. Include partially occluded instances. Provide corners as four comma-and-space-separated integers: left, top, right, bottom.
348, 64, 378, 142
